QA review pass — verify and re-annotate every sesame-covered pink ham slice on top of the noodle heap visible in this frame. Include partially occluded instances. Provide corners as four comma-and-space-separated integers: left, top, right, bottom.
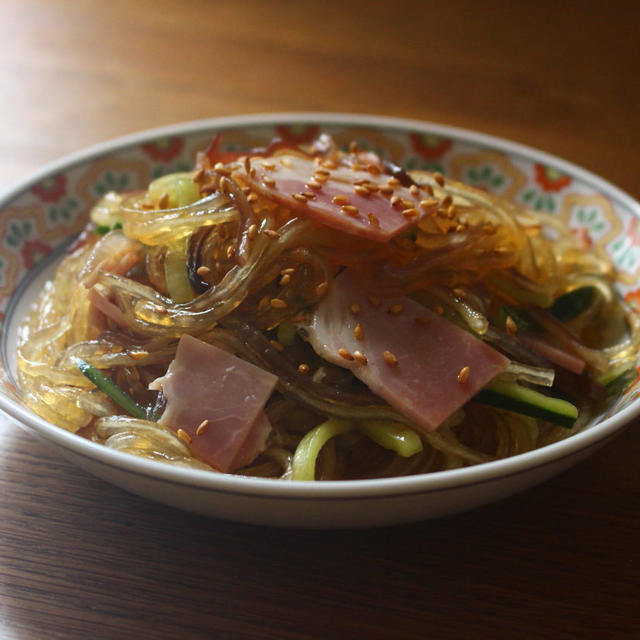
233, 153, 437, 242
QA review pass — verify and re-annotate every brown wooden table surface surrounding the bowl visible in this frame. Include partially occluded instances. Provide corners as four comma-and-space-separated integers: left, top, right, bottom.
0, 0, 640, 640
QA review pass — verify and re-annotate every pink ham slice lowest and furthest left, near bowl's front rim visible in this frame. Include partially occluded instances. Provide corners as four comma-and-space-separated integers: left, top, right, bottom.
150, 335, 277, 473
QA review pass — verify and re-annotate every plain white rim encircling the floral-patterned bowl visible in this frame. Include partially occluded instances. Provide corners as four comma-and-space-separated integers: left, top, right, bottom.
0, 112, 640, 501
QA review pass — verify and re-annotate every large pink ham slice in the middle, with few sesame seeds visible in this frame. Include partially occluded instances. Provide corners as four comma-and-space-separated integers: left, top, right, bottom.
306, 271, 509, 431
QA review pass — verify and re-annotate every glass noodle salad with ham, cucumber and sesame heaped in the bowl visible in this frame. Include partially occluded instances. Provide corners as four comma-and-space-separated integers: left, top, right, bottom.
18, 136, 638, 480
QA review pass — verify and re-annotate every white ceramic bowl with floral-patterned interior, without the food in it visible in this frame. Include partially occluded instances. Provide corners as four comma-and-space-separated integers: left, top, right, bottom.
0, 113, 640, 527
